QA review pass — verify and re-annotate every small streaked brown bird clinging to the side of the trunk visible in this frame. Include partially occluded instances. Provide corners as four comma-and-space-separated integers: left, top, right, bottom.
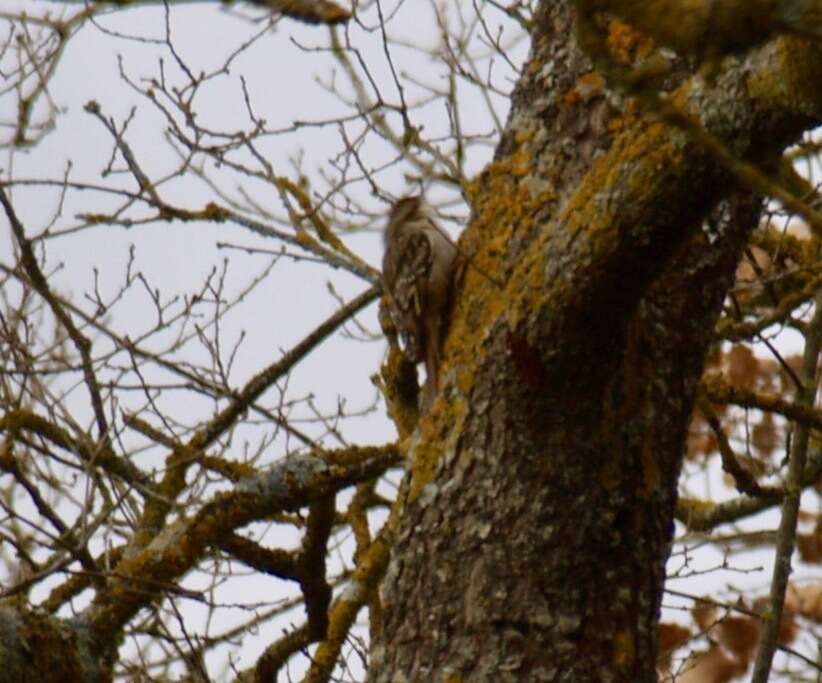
382, 195, 457, 409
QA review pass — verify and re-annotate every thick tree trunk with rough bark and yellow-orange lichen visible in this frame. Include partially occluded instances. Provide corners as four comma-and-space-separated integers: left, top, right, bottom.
368, 2, 822, 683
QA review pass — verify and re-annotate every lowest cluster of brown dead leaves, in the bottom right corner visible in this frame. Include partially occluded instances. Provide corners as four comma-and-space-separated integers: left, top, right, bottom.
659, 584, 822, 683
